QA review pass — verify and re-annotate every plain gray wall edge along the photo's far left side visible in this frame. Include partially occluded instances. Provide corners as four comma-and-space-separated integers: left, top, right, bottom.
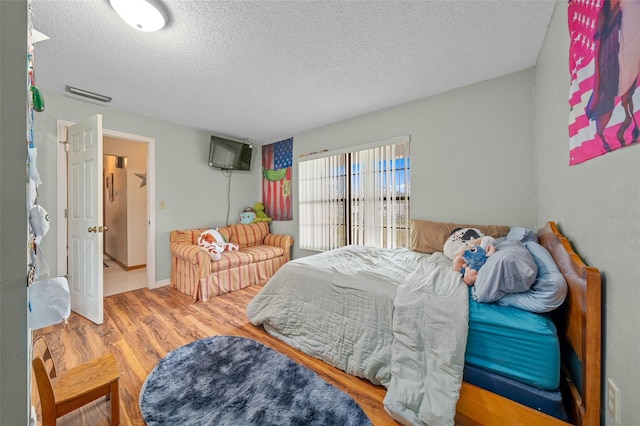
0, 1, 29, 425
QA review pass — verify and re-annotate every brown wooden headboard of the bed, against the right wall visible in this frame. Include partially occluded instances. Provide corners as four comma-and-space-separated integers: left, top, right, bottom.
538, 222, 602, 426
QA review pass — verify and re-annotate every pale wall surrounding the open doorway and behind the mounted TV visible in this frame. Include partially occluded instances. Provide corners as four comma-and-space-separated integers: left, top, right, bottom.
35, 90, 262, 281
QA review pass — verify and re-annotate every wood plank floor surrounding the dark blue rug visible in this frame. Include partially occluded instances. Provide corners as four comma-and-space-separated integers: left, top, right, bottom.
32, 287, 398, 426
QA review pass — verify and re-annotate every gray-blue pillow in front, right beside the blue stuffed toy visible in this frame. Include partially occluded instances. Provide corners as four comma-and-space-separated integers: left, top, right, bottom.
473, 240, 538, 303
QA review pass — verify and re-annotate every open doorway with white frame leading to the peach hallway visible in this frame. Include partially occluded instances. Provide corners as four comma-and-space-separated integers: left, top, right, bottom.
56, 120, 157, 297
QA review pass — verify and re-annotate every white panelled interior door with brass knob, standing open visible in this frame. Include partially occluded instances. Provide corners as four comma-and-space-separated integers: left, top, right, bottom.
67, 114, 104, 324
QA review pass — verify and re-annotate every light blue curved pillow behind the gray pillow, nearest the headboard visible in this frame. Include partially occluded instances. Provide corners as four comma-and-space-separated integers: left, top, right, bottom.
498, 241, 567, 313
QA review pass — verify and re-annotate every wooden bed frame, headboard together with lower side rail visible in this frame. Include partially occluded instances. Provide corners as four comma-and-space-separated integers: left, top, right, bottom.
456, 222, 602, 426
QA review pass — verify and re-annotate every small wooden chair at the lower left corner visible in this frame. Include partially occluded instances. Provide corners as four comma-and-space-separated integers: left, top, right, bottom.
31, 336, 120, 426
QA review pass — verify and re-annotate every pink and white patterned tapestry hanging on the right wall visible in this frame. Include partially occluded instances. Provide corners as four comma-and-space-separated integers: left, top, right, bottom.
568, 0, 640, 165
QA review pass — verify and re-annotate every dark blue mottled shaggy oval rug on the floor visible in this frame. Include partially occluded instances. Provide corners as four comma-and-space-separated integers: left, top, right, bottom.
140, 336, 371, 426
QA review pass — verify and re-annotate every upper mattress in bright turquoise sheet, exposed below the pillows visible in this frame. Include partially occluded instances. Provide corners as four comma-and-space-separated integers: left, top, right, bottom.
465, 297, 560, 391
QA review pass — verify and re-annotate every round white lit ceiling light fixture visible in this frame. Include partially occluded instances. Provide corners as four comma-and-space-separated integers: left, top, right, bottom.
109, 0, 169, 32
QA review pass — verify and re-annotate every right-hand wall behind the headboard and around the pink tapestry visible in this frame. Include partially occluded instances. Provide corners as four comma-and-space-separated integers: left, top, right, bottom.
535, 1, 640, 425
